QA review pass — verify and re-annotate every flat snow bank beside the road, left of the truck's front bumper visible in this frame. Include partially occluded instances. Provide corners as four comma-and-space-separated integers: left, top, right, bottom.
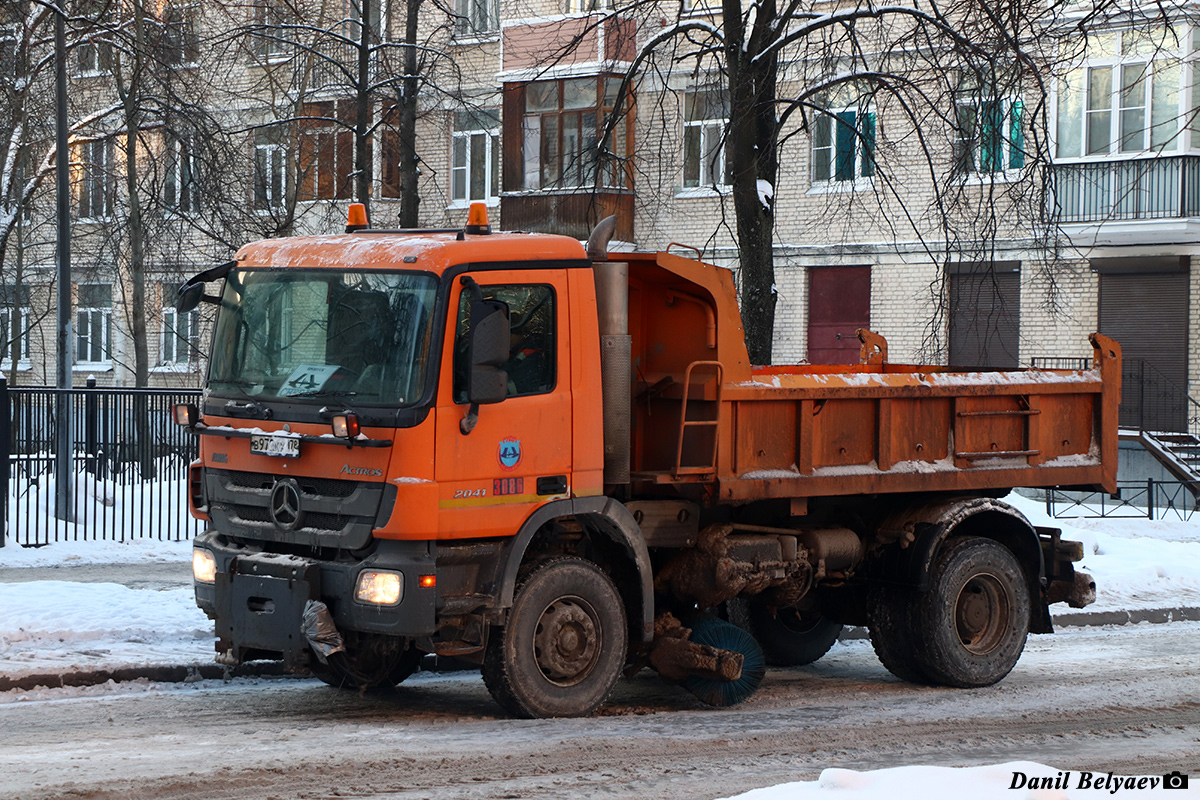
0, 578, 214, 678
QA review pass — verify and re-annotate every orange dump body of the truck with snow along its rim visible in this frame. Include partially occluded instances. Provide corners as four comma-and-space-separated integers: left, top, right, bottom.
614, 253, 1121, 503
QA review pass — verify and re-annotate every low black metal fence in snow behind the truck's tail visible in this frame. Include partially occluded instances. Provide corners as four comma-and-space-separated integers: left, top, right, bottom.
1046, 479, 1200, 522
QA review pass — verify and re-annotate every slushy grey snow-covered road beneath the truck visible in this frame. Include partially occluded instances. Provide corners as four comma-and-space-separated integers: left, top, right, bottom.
0, 622, 1200, 800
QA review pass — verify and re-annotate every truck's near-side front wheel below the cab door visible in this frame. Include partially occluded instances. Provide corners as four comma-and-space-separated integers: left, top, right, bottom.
482, 558, 629, 718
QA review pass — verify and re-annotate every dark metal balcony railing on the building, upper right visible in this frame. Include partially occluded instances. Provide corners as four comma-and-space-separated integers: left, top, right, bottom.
1054, 156, 1200, 223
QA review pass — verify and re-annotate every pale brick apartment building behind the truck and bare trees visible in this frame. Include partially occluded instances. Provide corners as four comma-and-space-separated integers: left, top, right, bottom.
0, 0, 1200, 438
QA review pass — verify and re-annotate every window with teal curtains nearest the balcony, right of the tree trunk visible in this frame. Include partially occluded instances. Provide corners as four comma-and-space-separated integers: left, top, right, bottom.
954, 92, 1025, 173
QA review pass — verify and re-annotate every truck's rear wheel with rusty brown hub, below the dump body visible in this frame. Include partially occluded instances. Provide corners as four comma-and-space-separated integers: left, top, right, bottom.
912, 536, 1030, 688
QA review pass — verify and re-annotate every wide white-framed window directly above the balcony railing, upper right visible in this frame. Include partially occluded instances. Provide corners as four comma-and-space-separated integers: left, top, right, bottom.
1056, 28, 1187, 158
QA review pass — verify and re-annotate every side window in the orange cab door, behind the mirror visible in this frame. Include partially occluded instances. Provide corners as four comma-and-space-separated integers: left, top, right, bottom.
454, 284, 556, 403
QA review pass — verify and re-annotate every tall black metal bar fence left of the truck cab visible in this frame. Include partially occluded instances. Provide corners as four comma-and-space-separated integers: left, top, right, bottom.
0, 379, 199, 546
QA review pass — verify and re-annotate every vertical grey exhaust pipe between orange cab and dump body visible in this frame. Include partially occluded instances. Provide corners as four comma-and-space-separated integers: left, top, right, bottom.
588, 216, 634, 485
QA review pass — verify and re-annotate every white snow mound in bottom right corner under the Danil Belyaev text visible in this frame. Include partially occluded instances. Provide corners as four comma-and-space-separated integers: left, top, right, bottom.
726, 762, 1176, 800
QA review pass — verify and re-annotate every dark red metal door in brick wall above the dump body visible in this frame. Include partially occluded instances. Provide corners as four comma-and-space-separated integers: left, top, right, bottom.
809, 266, 871, 363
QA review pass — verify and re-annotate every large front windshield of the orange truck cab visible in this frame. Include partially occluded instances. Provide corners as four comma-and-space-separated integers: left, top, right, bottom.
209, 269, 437, 405
